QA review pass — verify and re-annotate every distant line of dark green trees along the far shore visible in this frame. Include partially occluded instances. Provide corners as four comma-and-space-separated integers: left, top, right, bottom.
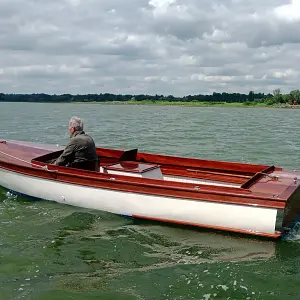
0, 89, 300, 105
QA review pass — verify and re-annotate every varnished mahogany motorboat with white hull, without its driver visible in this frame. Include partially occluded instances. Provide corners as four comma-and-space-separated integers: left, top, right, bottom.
0, 140, 300, 238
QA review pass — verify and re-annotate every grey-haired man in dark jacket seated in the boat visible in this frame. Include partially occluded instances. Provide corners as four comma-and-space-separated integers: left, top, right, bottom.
54, 117, 99, 171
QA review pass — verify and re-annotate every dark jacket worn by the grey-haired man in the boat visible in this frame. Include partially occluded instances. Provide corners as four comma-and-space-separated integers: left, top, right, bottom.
55, 131, 98, 169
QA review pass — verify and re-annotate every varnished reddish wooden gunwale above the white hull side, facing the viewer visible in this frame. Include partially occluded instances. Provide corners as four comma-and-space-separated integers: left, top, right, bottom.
0, 163, 286, 209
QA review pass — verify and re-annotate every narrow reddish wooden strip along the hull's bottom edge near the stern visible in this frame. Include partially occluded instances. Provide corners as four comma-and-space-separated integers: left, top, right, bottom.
132, 215, 281, 239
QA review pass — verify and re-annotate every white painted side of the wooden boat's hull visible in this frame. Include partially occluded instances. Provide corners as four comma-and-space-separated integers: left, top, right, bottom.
0, 169, 277, 234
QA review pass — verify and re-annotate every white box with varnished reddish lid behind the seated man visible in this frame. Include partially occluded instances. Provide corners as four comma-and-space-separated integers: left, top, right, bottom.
103, 161, 163, 179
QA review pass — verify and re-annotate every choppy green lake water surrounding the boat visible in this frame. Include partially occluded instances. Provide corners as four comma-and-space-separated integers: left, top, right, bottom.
0, 103, 300, 300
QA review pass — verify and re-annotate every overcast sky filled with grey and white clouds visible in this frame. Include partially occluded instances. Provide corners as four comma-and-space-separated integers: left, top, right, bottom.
0, 0, 300, 96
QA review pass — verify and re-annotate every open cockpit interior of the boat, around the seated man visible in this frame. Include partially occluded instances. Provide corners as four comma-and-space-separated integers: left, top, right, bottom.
34, 148, 244, 188
